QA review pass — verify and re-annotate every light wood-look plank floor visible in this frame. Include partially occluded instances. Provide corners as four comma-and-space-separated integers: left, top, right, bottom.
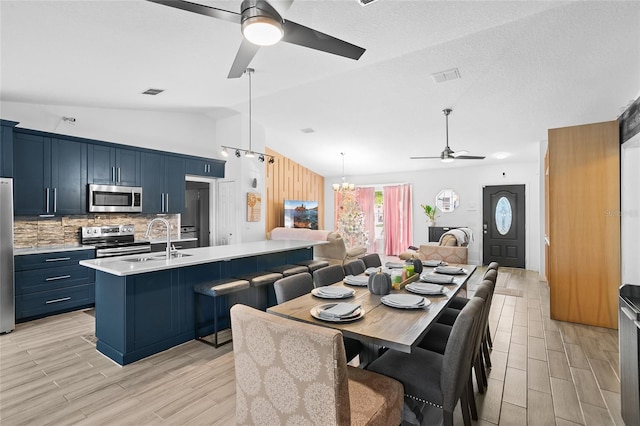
0, 268, 624, 426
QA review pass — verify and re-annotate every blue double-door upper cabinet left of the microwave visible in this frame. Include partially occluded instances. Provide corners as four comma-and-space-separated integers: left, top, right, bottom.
13, 132, 87, 215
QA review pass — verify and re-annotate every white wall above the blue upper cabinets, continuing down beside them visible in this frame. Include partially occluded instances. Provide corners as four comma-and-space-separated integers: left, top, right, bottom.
0, 102, 266, 242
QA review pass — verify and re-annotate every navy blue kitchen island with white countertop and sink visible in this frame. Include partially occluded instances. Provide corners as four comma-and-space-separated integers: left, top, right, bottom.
80, 240, 326, 365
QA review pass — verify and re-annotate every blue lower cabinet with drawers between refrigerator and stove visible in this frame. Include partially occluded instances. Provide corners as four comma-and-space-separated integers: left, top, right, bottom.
14, 249, 95, 322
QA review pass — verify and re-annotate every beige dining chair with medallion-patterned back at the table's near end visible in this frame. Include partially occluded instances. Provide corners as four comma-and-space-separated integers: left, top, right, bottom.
231, 305, 403, 425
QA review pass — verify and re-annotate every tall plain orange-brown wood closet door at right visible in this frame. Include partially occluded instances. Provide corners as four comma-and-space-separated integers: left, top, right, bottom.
548, 121, 621, 328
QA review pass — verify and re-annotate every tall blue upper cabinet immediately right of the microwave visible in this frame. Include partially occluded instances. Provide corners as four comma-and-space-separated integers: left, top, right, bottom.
141, 152, 185, 214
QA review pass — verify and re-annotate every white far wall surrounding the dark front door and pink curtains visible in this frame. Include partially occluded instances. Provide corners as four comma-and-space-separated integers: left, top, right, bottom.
325, 163, 544, 271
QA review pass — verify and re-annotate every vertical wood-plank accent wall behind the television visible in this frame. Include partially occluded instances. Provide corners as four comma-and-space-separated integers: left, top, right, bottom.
265, 148, 325, 233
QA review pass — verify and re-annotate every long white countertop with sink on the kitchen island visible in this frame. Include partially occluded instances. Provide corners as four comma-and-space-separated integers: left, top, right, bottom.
80, 240, 327, 276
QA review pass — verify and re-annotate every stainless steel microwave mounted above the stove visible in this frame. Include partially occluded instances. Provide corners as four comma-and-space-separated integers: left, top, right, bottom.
89, 184, 142, 213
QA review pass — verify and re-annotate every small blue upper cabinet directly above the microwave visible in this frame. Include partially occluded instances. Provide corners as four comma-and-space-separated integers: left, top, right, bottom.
88, 144, 140, 186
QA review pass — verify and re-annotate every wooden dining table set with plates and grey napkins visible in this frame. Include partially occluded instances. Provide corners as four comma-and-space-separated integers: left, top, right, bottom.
267, 265, 476, 363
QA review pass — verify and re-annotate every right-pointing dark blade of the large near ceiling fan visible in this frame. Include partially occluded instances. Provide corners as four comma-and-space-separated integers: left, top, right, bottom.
282, 21, 365, 60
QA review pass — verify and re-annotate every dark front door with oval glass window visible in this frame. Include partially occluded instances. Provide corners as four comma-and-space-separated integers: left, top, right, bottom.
482, 185, 525, 268
